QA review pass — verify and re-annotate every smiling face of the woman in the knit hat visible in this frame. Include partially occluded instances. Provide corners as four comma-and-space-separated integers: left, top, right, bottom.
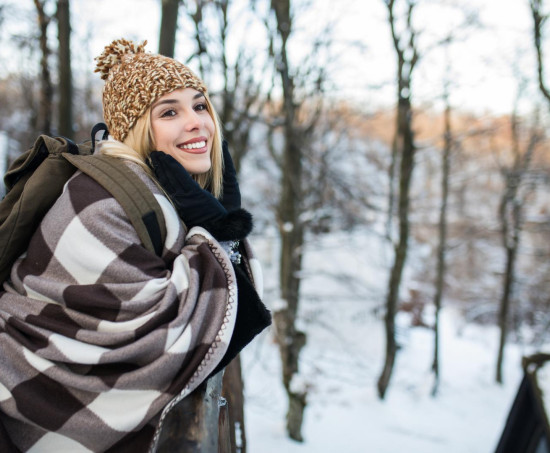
151, 88, 215, 175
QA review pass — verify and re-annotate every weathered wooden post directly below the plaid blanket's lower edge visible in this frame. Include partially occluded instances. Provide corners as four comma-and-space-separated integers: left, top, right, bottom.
157, 373, 231, 453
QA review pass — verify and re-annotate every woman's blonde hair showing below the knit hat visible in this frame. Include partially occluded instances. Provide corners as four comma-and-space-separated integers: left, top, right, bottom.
99, 94, 223, 198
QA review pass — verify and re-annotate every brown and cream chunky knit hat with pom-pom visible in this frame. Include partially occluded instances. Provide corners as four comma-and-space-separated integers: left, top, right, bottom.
95, 39, 207, 141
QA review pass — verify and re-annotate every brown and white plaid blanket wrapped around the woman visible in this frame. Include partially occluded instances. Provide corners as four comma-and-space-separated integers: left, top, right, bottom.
0, 164, 257, 452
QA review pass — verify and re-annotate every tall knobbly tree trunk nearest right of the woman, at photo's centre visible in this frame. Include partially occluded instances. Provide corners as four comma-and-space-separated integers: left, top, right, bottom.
271, 0, 307, 442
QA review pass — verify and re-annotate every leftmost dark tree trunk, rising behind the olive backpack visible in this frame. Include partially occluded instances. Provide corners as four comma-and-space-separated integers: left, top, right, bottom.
34, 0, 53, 135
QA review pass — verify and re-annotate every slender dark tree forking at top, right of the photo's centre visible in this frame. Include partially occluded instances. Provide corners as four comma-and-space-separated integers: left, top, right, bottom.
377, 0, 419, 399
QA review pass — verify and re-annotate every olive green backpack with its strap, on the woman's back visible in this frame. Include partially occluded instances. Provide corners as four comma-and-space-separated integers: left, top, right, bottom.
0, 123, 166, 282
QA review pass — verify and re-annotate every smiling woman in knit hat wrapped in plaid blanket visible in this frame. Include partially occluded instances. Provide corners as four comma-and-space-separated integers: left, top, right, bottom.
0, 40, 271, 452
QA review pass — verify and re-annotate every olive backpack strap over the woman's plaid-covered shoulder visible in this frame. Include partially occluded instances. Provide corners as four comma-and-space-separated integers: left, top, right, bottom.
62, 153, 166, 256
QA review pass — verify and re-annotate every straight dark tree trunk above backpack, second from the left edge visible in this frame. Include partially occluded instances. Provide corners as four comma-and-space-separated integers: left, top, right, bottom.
57, 0, 74, 139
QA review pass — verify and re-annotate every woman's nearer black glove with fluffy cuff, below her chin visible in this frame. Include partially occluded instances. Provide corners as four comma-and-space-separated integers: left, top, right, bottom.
149, 151, 252, 241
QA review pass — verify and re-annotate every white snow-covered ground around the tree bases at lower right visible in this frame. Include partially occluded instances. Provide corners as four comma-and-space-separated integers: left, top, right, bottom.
242, 233, 532, 453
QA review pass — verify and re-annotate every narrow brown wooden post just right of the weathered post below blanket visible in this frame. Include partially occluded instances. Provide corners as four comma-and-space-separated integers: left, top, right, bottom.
222, 356, 246, 453
